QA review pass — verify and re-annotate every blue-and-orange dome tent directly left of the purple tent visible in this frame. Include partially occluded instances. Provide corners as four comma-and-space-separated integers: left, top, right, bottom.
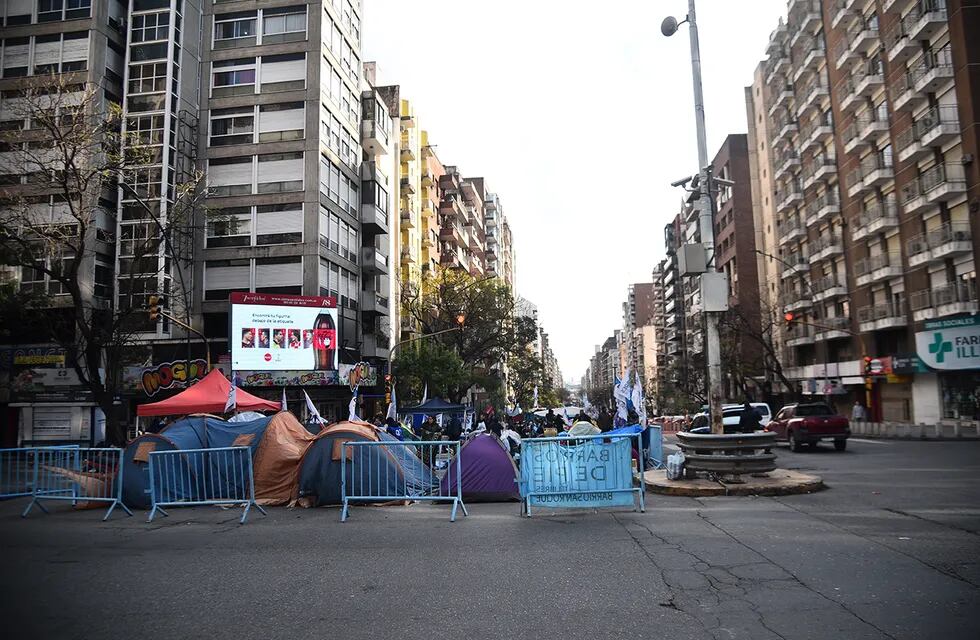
298, 422, 438, 507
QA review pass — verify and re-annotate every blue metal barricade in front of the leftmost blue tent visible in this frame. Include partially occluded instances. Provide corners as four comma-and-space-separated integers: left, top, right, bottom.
146, 447, 267, 524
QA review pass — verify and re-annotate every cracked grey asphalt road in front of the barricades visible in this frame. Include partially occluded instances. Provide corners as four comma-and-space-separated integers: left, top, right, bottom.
0, 440, 980, 640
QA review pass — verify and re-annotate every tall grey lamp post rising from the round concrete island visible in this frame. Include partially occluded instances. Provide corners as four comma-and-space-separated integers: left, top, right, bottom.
660, 0, 724, 434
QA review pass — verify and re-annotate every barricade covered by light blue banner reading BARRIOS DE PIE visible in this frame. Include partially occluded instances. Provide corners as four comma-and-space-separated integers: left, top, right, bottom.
521, 434, 646, 516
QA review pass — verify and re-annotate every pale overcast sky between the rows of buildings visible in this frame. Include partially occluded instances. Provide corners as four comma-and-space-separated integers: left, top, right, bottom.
363, 0, 786, 379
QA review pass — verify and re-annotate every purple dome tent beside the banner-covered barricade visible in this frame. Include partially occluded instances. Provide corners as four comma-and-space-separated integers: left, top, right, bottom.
442, 435, 521, 502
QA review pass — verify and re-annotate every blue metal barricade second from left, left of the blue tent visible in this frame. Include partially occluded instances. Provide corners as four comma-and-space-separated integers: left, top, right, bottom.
21, 447, 133, 522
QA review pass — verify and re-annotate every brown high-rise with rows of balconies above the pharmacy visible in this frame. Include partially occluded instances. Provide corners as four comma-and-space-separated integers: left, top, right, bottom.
749, 0, 980, 423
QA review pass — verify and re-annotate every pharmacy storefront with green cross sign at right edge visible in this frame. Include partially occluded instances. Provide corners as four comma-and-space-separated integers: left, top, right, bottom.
915, 316, 980, 423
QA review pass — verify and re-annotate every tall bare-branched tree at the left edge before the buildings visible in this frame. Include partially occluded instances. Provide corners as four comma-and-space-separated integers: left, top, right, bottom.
0, 76, 202, 444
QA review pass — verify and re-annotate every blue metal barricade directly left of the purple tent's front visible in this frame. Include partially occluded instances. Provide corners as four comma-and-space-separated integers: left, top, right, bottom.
340, 440, 469, 522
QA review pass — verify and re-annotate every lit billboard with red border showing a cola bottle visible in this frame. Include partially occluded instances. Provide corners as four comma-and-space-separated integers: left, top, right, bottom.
228, 292, 338, 371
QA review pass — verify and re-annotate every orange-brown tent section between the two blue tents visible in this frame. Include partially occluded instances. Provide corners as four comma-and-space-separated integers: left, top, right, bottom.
252, 411, 316, 505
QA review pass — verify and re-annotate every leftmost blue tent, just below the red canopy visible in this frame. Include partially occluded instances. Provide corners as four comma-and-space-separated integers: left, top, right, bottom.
122, 416, 271, 509
